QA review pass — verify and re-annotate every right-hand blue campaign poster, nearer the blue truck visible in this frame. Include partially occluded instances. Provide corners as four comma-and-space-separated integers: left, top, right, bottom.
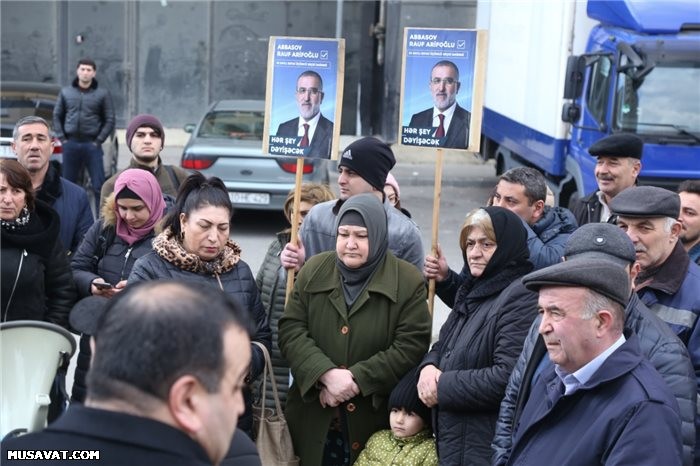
398, 28, 486, 152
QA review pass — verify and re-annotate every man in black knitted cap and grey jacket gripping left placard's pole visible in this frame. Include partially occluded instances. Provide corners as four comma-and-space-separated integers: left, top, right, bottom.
280, 137, 423, 271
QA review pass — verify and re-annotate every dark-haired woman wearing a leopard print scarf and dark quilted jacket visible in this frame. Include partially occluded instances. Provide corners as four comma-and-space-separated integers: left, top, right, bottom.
128, 173, 271, 434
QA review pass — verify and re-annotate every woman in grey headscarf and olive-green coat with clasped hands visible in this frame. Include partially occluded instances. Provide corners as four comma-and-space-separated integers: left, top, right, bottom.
279, 194, 431, 466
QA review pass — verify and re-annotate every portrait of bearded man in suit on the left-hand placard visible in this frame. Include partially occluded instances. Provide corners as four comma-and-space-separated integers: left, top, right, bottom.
276, 70, 333, 159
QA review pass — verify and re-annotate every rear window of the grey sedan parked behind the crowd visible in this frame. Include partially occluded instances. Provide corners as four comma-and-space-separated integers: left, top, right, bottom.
197, 110, 264, 141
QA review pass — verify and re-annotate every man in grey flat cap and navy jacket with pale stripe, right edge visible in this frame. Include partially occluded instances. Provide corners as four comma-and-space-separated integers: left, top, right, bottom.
610, 186, 700, 461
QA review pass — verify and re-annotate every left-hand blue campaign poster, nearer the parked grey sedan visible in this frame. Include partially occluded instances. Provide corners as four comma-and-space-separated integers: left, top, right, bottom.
263, 37, 345, 159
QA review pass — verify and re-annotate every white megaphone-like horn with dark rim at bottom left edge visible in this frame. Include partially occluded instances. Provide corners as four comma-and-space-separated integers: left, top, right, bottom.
0, 320, 76, 438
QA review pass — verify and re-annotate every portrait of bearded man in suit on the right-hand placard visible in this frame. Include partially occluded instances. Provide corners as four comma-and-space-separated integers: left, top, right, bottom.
408, 60, 471, 149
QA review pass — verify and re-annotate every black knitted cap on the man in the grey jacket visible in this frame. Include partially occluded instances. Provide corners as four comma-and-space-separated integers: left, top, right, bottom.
338, 137, 396, 191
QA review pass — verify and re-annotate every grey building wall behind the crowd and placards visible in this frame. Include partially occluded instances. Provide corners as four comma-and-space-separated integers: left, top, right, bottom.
0, 0, 476, 141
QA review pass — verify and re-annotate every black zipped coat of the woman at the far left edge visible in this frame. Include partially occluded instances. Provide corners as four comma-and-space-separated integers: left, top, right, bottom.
0, 200, 76, 328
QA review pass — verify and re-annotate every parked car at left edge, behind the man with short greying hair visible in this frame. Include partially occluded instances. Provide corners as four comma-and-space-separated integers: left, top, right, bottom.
0, 81, 119, 179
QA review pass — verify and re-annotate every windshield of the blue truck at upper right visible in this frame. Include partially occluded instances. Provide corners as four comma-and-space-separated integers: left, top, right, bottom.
615, 62, 700, 137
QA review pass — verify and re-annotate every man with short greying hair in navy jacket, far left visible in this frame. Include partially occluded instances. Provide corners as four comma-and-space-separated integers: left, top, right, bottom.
12, 116, 93, 254
